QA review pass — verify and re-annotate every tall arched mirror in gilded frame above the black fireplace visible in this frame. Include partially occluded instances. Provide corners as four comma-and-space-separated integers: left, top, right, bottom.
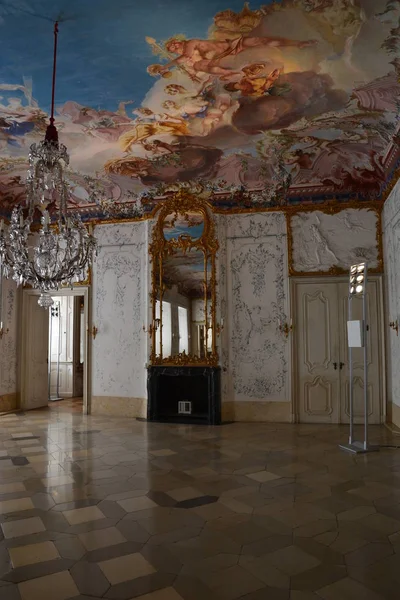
150, 192, 218, 366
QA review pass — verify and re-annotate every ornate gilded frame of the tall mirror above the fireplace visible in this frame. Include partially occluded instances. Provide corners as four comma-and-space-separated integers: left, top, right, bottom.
149, 190, 219, 366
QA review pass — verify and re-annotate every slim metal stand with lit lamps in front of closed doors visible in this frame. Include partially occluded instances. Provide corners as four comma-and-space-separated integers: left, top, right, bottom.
339, 263, 379, 454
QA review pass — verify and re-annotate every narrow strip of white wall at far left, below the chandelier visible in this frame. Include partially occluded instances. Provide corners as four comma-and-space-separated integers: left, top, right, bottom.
0, 279, 20, 412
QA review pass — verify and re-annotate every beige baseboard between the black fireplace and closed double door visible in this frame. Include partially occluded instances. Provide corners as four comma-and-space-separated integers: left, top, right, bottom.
222, 402, 292, 423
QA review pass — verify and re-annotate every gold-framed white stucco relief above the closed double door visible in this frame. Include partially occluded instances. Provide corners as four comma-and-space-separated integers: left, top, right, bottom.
290, 208, 379, 273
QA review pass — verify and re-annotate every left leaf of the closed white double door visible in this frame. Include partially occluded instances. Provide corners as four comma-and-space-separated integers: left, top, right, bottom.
294, 283, 340, 423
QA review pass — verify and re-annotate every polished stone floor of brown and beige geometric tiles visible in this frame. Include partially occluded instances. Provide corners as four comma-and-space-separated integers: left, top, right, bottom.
0, 410, 400, 600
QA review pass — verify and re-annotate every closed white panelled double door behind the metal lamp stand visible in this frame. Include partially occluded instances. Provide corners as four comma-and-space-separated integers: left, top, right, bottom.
294, 279, 383, 424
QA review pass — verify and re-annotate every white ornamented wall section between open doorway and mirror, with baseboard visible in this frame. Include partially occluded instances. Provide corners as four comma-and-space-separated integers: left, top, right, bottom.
92, 222, 149, 416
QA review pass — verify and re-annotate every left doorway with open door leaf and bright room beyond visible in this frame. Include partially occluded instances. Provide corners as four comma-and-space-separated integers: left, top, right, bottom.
20, 287, 88, 414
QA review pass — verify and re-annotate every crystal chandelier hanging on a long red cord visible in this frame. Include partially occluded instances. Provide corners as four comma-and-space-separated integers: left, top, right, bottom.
0, 22, 96, 308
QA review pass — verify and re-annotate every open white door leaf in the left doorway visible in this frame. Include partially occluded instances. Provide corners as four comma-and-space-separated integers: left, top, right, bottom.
21, 293, 49, 410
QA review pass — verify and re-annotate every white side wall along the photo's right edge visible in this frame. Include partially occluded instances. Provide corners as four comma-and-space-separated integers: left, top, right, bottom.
382, 182, 400, 427
